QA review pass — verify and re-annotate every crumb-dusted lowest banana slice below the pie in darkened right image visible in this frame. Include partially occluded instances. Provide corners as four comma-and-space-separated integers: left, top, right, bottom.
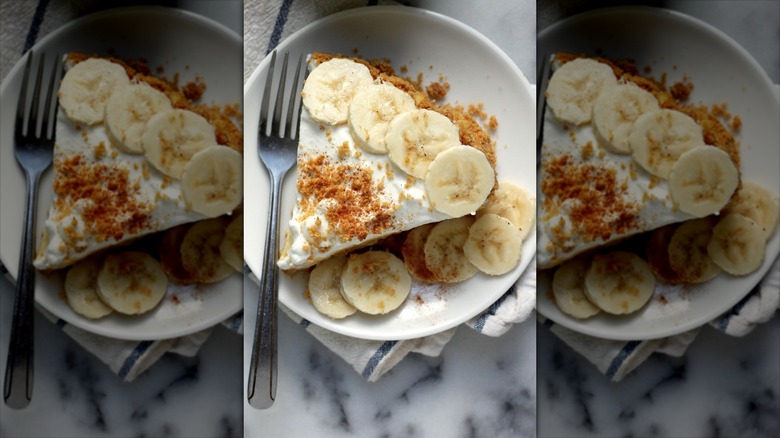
585, 251, 655, 315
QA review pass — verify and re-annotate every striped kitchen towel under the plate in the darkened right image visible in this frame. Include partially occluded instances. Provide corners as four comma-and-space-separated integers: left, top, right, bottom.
537, 258, 780, 382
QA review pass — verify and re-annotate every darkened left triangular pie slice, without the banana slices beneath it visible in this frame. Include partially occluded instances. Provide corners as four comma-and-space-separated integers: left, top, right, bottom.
34, 53, 243, 270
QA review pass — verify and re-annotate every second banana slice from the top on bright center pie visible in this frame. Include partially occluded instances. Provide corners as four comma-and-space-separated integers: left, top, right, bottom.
347, 82, 416, 154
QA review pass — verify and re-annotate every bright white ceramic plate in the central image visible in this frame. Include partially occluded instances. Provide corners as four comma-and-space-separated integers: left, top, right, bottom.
244, 7, 536, 340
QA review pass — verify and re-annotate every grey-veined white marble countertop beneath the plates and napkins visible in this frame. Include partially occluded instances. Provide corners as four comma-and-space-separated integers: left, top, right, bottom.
0, 0, 780, 438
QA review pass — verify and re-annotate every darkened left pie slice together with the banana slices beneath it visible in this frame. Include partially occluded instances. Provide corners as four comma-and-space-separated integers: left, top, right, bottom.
34, 53, 243, 318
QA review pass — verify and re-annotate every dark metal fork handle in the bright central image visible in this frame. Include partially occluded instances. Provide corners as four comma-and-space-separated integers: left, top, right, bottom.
247, 174, 284, 409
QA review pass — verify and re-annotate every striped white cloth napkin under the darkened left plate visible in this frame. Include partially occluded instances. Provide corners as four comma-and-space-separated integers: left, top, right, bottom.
0, 0, 243, 382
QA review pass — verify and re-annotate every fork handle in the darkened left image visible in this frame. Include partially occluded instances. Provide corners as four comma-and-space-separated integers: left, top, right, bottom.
3, 173, 38, 409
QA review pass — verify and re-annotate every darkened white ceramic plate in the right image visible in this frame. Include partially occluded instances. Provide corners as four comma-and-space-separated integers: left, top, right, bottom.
537, 7, 780, 340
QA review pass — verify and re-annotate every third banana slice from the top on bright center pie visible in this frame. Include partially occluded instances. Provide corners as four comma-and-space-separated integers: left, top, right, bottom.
385, 109, 460, 179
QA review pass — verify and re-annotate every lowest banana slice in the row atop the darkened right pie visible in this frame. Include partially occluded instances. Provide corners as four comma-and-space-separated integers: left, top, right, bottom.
669, 146, 739, 217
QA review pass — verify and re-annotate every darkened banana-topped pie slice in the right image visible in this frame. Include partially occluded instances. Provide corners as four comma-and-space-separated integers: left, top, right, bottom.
537, 53, 739, 268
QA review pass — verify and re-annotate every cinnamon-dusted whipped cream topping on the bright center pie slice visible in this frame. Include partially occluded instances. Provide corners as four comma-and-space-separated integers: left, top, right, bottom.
278, 107, 451, 270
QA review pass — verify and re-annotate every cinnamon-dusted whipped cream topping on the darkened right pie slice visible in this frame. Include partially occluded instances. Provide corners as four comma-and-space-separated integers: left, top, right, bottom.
537, 107, 693, 268
